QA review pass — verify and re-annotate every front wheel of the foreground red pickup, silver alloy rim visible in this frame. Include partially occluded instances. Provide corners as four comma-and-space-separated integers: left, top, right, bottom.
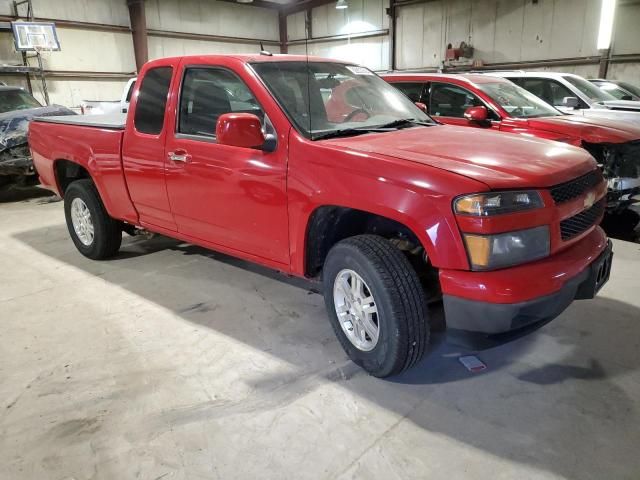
322, 235, 429, 377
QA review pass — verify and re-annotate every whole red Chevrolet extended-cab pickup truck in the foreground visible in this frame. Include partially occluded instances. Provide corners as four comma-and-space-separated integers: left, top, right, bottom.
29, 55, 612, 377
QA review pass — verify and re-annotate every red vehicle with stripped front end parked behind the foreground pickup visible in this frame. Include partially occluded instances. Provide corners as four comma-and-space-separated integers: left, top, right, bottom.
382, 73, 640, 212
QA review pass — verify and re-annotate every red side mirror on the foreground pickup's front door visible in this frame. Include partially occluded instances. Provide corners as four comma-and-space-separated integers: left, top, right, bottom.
216, 113, 275, 152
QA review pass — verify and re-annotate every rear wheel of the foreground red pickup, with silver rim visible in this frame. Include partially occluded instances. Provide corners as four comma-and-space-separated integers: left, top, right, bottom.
64, 179, 122, 260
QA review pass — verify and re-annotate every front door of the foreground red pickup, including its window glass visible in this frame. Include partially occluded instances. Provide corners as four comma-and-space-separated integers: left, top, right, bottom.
165, 66, 289, 265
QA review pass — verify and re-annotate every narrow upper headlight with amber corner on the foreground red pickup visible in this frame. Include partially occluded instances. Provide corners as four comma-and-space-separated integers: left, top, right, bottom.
453, 190, 544, 217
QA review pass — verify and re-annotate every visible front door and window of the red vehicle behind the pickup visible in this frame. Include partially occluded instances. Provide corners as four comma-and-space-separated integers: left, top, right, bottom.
426, 82, 500, 130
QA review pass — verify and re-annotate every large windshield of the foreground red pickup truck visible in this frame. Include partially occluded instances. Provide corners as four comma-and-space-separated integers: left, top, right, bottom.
252, 62, 435, 140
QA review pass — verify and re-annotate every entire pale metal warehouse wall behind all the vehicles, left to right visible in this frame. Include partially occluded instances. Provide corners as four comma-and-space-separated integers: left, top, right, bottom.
0, 0, 640, 107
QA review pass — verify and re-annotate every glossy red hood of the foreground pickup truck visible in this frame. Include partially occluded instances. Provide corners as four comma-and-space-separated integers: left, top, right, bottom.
323, 125, 596, 189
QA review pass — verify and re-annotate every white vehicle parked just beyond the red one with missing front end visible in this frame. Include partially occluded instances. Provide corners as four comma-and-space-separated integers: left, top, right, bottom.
487, 71, 640, 124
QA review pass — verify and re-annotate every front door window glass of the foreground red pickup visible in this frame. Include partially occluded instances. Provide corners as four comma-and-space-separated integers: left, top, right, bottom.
178, 68, 264, 137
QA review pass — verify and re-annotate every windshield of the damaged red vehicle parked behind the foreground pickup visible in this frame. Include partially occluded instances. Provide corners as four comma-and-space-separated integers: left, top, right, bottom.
478, 82, 562, 118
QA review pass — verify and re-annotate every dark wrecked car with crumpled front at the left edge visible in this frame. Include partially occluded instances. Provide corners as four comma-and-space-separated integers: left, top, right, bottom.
0, 86, 75, 187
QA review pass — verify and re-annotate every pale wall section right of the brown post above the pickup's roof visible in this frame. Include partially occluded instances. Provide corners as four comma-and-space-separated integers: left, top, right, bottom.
287, 0, 640, 83
